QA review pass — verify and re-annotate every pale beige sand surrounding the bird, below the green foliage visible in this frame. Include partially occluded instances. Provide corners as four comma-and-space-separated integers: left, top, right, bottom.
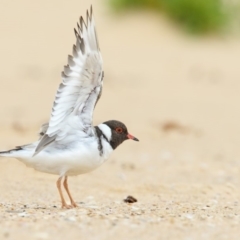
0, 0, 240, 240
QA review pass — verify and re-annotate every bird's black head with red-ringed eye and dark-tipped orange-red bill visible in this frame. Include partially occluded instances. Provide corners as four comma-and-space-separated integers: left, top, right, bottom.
103, 120, 139, 149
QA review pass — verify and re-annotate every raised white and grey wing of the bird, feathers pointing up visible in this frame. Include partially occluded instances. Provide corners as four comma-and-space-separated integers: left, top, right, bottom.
35, 7, 103, 155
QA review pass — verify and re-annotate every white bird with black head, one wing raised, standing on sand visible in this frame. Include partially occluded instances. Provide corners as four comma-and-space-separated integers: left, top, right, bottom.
0, 6, 139, 209
